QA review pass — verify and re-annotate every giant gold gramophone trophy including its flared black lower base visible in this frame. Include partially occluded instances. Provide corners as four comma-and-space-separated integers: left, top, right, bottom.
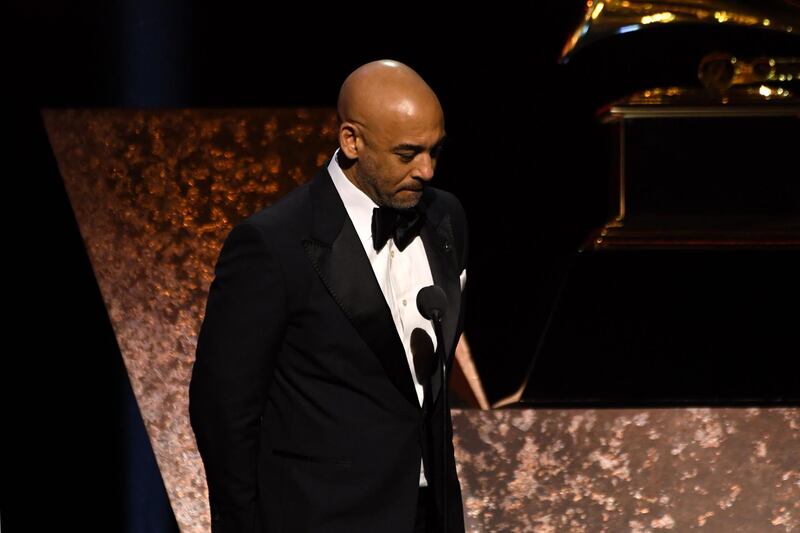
510, 0, 800, 406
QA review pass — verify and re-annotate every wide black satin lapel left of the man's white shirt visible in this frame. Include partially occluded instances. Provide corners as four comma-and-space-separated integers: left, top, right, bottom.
303, 169, 419, 406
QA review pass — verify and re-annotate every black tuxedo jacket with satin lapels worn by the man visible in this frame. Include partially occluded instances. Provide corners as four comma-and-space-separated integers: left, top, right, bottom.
189, 164, 467, 533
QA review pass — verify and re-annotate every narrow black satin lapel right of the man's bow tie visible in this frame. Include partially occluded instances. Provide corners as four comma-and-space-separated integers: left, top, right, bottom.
420, 204, 461, 404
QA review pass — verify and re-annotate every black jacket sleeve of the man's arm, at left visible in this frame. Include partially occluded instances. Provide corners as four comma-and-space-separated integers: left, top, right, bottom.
189, 222, 287, 533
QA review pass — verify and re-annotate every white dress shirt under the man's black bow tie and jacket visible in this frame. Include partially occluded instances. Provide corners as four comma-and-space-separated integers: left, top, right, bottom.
328, 150, 466, 487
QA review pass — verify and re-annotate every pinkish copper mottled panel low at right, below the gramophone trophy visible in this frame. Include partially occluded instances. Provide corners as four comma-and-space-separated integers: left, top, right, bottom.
453, 408, 800, 533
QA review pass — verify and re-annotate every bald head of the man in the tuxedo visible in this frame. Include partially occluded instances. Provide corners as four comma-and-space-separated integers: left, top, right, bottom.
338, 60, 444, 209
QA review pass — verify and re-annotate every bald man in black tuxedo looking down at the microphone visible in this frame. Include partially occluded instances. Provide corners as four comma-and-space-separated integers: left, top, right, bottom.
189, 60, 467, 533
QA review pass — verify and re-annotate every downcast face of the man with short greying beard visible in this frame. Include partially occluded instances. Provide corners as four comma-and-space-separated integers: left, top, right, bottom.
356, 113, 445, 209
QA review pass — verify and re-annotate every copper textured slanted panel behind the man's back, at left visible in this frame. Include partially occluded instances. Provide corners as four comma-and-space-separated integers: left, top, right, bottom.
43, 109, 336, 532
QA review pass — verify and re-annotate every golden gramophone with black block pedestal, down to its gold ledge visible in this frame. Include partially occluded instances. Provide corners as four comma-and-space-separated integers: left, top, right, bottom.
561, 0, 800, 249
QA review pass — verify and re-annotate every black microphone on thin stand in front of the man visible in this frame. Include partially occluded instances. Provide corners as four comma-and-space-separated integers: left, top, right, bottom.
417, 285, 450, 533
